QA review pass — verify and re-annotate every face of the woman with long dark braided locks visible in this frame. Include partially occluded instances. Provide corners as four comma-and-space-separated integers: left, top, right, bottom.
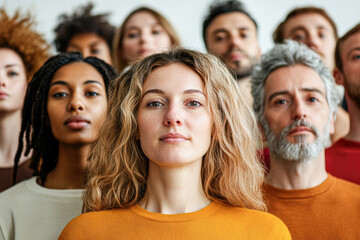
47, 62, 107, 145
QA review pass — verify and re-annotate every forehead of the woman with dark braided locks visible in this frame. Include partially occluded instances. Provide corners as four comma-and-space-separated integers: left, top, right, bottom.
51, 62, 104, 83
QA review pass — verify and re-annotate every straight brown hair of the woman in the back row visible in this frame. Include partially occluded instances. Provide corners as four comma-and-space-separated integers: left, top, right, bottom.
113, 7, 180, 73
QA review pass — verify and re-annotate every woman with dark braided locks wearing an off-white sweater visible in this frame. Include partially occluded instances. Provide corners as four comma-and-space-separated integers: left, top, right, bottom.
0, 53, 116, 240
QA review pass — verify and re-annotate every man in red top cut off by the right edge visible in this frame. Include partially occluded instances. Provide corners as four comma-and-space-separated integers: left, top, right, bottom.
325, 23, 360, 184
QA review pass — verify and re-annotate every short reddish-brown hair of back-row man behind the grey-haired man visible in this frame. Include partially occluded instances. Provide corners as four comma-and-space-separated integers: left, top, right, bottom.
273, 7, 338, 43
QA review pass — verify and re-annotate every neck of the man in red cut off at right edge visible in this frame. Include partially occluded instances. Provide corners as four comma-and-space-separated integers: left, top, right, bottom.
345, 96, 360, 142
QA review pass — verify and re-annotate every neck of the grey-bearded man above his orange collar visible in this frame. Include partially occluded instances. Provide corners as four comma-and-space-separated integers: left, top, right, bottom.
266, 151, 327, 190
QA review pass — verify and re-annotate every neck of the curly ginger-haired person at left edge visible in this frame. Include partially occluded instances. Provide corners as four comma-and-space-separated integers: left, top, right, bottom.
0, 110, 25, 167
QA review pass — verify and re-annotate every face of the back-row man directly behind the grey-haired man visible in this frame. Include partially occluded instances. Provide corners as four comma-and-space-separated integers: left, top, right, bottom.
283, 13, 336, 70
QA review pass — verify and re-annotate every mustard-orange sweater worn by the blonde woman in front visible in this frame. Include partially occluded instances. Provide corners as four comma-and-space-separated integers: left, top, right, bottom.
59, 202, 291, 240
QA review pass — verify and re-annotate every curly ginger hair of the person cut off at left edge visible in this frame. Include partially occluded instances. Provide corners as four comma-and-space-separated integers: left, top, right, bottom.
0, 8, 49, 81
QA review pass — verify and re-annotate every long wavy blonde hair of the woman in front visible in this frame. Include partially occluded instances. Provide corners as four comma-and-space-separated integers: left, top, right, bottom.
84, 48, 266, 212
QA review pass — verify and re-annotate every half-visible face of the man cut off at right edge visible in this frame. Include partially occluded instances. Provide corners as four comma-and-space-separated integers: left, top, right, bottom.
341, 32, 360, 109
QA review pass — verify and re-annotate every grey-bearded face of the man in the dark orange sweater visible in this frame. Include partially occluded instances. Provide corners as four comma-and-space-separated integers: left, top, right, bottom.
261, 64, 333, 162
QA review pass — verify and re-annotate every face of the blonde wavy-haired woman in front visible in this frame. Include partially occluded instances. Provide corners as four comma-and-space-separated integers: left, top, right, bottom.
137, 63, 213, 166
